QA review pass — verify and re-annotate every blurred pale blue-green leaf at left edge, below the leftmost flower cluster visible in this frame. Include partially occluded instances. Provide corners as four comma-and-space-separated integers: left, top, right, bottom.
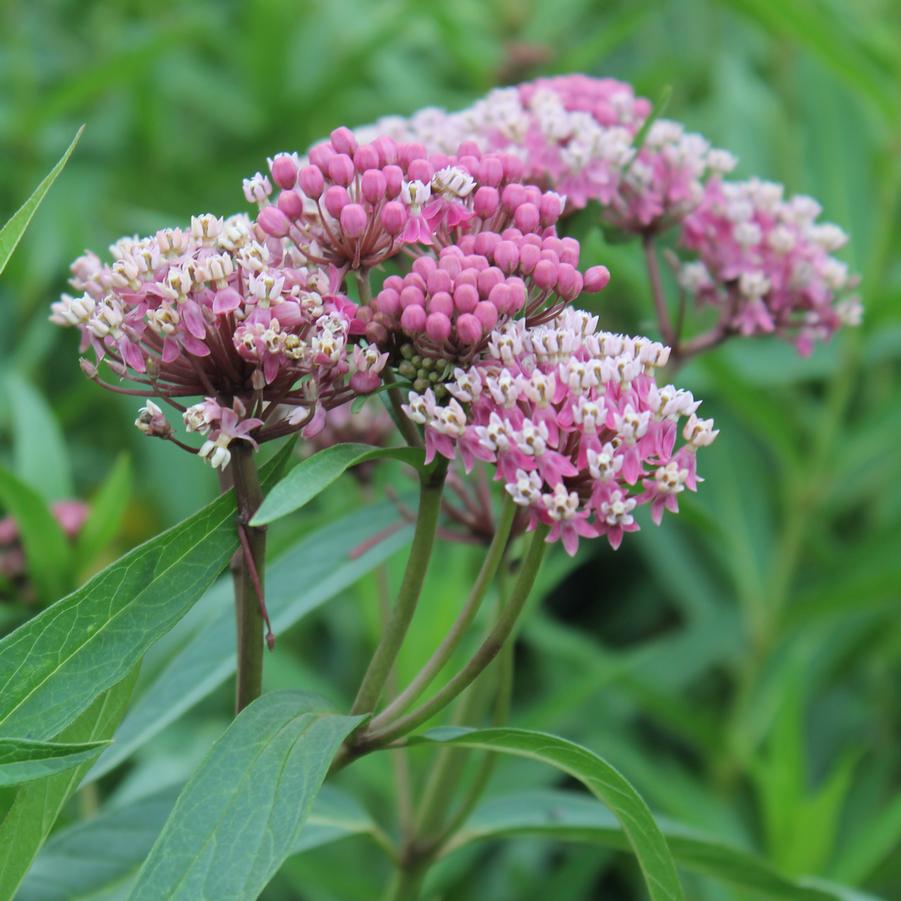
6, 373, 75, 501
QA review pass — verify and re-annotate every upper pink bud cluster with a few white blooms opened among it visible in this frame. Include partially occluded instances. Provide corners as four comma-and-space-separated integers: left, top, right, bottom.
244, 128, 564, 271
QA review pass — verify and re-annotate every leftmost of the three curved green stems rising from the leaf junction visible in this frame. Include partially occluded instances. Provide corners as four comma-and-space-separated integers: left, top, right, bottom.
351, 460, 447, 714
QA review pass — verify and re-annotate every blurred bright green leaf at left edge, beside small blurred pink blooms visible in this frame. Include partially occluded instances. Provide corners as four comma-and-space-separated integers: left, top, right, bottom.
0, 467, 72, 600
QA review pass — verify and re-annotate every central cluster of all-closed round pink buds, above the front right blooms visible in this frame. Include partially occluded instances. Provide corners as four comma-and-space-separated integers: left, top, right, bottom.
360, 228, 610, 372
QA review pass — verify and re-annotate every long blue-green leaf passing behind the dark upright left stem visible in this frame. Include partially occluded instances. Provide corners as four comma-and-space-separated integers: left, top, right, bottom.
90, 502, 412, 779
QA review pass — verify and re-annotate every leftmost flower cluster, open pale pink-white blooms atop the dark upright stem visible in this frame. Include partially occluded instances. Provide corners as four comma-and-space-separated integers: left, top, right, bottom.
51, 215, 386, 466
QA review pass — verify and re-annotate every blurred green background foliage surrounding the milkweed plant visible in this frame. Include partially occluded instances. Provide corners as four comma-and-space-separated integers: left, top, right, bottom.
0, 0, 901, 901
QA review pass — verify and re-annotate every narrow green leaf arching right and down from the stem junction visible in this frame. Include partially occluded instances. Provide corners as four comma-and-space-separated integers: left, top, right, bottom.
408, 726, 684, 901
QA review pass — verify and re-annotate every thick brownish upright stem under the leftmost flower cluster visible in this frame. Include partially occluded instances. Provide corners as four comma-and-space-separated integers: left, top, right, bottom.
230, 441, 266, 713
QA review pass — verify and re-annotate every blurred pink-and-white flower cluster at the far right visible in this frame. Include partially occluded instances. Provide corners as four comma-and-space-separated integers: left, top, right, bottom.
679, 179, 861, 354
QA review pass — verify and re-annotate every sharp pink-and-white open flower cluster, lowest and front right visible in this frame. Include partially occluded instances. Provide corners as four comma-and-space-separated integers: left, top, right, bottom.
404, 308, 717, 554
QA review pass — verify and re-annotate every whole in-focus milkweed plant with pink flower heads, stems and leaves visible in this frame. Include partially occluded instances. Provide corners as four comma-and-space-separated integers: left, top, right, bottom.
0, 75, 861, 901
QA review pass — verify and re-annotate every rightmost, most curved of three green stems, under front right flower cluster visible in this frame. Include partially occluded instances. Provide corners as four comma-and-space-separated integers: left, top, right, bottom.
355, 525, 548, 750
